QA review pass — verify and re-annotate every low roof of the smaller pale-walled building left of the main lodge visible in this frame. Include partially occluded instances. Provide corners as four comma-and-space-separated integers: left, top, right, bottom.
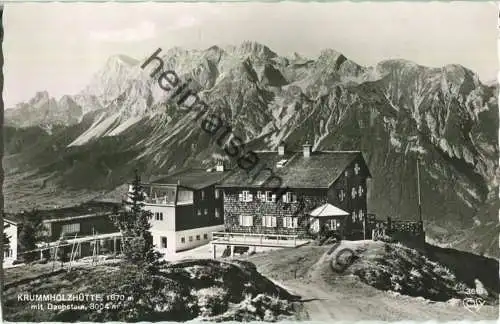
150, 168, 228, 190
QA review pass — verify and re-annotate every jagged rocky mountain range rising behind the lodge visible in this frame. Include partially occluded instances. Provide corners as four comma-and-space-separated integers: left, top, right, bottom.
5, 42, 499, 254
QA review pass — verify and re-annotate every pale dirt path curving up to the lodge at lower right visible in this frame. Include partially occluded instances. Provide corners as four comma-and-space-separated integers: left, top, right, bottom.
250, 244, 498, 321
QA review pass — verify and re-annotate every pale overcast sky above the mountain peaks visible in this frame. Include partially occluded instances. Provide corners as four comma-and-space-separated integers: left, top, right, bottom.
3, 2, 498, 107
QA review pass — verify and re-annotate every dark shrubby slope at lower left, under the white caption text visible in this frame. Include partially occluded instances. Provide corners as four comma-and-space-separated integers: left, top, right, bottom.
4, 260, 300, 322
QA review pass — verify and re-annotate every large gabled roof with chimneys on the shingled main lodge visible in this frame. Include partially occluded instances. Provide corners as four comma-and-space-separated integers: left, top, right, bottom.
220, 151, 364, 188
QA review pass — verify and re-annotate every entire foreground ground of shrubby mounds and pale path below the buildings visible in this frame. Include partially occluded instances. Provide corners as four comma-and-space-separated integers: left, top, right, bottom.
4, 241, 499, 321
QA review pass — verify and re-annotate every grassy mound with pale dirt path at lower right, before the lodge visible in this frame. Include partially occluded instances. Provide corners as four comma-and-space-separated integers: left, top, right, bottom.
248, 242, 498, 321
